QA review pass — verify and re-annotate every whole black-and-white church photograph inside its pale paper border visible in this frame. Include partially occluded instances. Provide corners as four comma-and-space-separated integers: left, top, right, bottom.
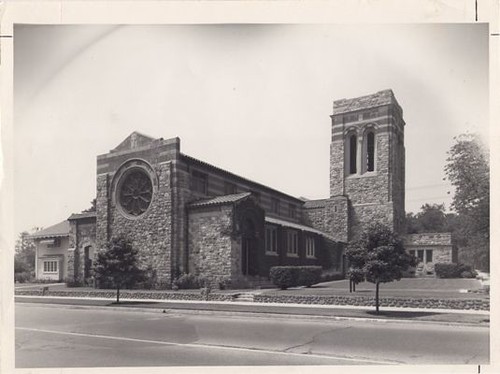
2, 4, 499, 373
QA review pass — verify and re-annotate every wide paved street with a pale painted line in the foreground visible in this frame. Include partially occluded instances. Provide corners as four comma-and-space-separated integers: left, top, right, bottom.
16, 304, 489, 368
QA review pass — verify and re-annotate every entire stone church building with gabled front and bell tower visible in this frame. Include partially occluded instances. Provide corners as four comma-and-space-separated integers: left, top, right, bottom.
32, 90, 453, 288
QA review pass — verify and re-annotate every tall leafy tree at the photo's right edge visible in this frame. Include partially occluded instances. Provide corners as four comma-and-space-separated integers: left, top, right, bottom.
445, 134, 490, 271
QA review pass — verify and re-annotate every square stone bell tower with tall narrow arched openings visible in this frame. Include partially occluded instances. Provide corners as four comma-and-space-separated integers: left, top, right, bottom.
330, 90, 405, 240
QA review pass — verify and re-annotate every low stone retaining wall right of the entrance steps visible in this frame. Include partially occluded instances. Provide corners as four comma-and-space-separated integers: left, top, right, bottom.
254, 295, 490, 310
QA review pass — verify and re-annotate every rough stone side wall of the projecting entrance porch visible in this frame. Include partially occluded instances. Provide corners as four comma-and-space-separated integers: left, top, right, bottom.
189, 205, 234, 279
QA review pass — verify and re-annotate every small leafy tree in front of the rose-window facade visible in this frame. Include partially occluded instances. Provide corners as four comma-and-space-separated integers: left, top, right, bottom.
94, 237, 143, 304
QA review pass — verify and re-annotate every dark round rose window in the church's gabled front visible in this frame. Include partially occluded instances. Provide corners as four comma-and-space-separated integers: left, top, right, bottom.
119, 170, 153, 216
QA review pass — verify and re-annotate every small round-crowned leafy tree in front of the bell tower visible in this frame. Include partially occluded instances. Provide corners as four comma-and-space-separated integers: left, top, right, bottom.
346, 223, 417, 313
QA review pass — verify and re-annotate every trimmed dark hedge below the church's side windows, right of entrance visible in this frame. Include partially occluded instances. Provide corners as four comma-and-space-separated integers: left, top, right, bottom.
269, 266, 321, 290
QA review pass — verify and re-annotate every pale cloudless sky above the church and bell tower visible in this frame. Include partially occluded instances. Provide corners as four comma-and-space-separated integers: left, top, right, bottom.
14, 23, 489, 233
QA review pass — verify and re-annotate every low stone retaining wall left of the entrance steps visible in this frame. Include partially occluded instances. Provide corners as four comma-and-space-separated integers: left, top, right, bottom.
15, 289, 233, 301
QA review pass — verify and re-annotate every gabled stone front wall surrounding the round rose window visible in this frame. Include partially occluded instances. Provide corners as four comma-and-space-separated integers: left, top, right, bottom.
96, 133, 180, 288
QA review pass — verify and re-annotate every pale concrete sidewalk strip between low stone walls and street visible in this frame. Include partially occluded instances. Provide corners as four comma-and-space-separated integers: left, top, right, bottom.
15, 296, 489, 325
